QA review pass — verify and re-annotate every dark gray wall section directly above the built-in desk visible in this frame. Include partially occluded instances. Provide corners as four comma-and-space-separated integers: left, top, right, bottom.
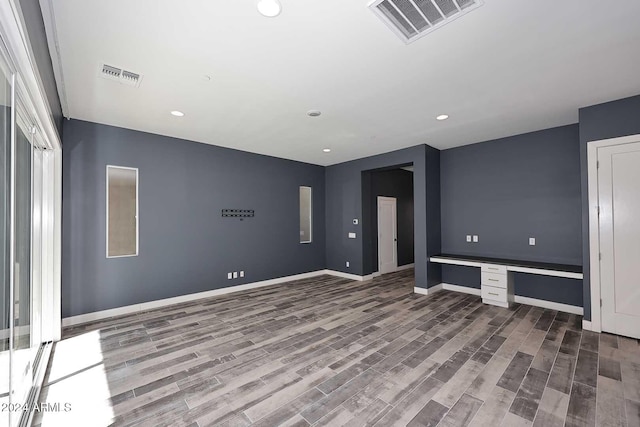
440, 125, 582, 265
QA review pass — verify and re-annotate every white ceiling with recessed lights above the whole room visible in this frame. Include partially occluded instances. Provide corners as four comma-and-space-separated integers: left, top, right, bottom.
43, 0, 640, 165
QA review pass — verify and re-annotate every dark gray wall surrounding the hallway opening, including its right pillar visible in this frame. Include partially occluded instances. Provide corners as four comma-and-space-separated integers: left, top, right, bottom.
325, 145, 441, 287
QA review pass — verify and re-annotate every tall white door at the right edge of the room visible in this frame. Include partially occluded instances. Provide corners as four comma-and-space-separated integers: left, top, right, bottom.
598, 142, 640, 338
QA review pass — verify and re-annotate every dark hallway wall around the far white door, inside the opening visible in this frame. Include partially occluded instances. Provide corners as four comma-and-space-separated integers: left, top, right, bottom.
362, 169, 414, 274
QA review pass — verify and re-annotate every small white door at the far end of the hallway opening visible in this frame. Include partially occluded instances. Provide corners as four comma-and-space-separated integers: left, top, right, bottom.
378, 196, 398, 274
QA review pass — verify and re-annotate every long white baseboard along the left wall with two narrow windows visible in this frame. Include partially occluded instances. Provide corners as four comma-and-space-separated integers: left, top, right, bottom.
62, 270, 328, 327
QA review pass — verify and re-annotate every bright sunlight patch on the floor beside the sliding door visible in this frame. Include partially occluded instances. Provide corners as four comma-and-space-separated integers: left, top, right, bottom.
34, 331, 114, 427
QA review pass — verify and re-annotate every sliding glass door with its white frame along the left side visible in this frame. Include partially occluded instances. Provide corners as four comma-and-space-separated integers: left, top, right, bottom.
0, 5, 62, 427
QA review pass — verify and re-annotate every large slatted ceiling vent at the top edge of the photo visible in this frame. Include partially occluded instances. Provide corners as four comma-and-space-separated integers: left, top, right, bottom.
369, 0, 484, 44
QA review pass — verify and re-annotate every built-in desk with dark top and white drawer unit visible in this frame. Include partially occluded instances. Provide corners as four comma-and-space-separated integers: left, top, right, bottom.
429, 254, 583, 307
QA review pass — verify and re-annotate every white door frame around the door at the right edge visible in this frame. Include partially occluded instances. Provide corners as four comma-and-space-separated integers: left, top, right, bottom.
583, 134, 640, 332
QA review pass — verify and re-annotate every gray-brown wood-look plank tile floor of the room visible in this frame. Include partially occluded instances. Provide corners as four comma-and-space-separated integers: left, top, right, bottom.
35, 270, 640, 427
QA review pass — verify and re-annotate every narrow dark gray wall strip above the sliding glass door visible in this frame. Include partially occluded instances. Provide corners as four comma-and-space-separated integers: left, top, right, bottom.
20, 0, 63, 135
